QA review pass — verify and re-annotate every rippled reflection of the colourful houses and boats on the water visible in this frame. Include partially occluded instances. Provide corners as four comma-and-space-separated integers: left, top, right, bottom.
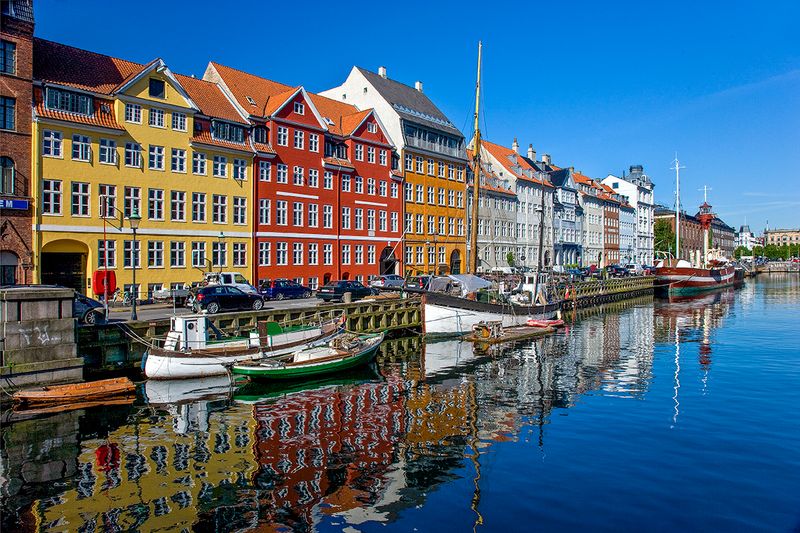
0, 293, 752, 531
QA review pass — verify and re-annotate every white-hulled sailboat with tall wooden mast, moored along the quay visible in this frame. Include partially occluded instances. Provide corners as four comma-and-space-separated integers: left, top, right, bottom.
422, 42, 561, 336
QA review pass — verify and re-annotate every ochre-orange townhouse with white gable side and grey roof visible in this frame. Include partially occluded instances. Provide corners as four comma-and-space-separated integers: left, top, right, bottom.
320, 67, 467, 274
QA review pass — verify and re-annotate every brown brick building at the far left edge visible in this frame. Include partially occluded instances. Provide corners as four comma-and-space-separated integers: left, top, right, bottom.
0, 0, 34, 285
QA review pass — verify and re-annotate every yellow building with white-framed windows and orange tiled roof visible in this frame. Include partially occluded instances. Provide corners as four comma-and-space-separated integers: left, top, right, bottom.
31, 39, 254, 298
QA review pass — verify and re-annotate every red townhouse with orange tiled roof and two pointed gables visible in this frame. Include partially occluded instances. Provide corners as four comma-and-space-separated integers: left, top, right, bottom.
204, 63, 403, 289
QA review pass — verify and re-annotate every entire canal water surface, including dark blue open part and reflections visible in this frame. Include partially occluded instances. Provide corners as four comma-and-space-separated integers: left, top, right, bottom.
0, 275, 800, 532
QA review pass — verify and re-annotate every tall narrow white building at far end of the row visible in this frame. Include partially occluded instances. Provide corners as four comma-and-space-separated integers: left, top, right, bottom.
603, 165, 655, 265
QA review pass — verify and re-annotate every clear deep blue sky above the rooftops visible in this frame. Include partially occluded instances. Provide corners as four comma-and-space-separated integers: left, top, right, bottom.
35, 0, 800, 233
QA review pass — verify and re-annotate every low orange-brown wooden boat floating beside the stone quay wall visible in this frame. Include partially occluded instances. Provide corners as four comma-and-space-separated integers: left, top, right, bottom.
13, 378, 136, 406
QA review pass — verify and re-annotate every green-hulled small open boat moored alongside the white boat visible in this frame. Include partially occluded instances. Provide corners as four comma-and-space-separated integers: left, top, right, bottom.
231, 333, 384, 381
